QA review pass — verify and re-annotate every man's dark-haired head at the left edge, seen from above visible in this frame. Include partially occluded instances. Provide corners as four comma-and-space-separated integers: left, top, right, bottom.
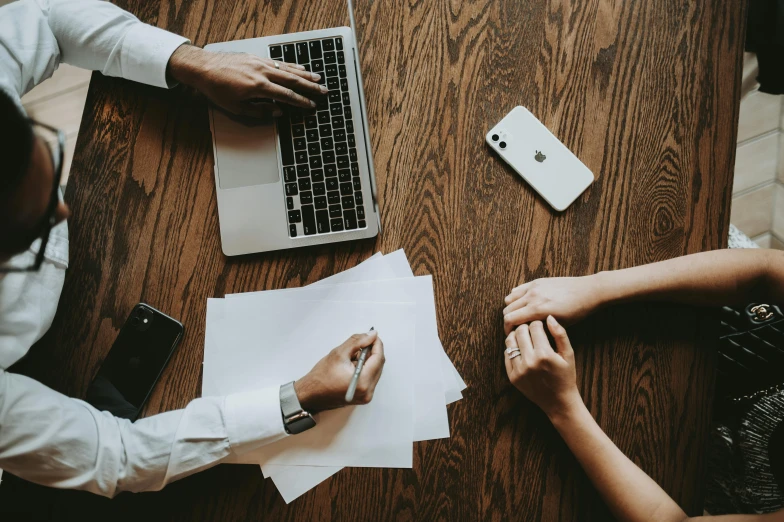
0, 90, 68, 263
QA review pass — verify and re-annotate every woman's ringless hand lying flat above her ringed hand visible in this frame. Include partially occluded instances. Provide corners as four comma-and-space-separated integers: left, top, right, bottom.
504, 276, 604, 335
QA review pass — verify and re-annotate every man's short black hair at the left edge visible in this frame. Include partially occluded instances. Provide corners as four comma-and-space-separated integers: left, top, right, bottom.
0, 89, 34, 204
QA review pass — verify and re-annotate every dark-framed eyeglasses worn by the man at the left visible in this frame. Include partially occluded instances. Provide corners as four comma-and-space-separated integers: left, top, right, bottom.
0, 119, 65, 274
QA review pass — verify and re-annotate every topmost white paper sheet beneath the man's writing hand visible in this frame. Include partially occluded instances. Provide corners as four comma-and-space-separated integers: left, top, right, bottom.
203, 294, 416, 468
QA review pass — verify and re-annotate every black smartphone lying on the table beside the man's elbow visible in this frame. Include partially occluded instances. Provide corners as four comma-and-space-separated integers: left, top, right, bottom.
87, 303, 184, 421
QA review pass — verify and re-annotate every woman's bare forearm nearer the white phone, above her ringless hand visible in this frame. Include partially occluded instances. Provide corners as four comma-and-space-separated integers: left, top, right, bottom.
592, 249, 784, 306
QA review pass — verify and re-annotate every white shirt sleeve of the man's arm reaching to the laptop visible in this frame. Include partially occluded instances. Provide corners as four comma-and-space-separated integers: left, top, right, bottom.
0, 0, 188, 104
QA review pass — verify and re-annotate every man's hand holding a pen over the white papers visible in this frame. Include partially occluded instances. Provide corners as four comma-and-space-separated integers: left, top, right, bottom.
294, 331, 384, 413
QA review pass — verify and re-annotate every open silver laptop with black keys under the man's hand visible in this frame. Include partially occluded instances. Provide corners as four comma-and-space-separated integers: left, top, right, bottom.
205, 0, 381, 256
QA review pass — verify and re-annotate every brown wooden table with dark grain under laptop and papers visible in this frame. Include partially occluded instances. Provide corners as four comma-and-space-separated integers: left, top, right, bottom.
0, 0, 746, 521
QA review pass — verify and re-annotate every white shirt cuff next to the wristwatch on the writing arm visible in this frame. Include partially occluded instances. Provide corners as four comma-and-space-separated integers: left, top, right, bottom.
224, 386, 286, 455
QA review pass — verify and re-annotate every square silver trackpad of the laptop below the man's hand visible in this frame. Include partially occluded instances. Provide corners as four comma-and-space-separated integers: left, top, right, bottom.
211, 109, 280, 189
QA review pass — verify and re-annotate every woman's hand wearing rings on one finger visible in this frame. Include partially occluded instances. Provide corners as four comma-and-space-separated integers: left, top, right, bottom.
504, 316, 583, 419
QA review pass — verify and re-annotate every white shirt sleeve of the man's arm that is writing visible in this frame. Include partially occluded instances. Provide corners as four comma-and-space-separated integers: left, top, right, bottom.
0, 370, 286, 497
